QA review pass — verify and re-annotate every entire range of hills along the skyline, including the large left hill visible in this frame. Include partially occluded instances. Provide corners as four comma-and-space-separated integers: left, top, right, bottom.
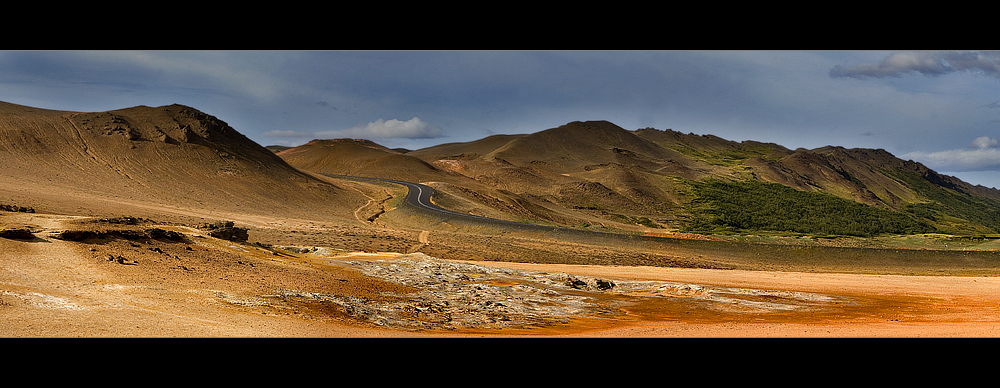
0, 102, 1000, 236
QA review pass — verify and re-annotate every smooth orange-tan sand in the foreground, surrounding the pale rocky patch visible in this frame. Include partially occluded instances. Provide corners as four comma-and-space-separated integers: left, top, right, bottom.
0, 213, 1000, 337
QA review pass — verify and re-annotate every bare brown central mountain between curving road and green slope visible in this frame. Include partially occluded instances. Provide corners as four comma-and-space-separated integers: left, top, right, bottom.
407, 121, 721, 223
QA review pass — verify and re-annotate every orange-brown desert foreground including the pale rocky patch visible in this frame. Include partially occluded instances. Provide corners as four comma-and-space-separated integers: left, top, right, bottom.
0, 206, 1000, 337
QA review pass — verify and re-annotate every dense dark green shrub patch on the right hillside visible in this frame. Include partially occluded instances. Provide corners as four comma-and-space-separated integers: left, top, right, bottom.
682, 179, 935, 237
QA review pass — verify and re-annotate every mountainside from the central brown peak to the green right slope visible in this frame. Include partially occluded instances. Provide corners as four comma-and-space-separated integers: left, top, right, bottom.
407, 121, 1000, 236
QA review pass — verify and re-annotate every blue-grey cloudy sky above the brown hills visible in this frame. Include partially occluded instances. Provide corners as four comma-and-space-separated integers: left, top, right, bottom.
0, 50, 1000, 188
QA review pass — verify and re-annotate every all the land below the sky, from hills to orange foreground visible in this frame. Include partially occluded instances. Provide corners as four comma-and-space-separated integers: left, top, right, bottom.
0, 103, 1000, 337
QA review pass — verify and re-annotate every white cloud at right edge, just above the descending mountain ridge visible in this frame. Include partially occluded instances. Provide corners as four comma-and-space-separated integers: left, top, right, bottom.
903, 136, 1000, 172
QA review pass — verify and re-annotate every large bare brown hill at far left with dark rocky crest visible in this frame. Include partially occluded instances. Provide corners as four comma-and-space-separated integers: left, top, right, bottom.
0, 103, 365, 223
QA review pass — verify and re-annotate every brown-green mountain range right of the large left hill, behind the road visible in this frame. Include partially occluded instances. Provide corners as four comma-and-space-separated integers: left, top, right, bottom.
277, 121, 1000, 236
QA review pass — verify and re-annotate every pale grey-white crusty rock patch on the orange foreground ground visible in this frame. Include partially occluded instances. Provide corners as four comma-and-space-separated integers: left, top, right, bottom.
260, 253, 849, 330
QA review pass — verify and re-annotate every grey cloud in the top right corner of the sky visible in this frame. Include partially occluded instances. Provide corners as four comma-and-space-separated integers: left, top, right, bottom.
830, 51, 1000, 79
